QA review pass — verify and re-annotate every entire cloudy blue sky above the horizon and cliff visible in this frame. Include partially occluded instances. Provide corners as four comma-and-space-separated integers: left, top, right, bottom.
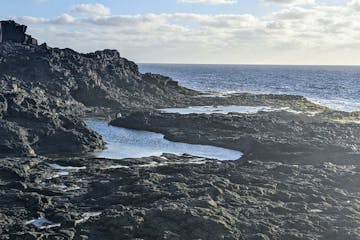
0, 0, 360, 65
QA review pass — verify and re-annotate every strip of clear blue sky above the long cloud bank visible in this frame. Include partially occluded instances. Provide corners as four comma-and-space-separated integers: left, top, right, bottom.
4, 0, 277, 17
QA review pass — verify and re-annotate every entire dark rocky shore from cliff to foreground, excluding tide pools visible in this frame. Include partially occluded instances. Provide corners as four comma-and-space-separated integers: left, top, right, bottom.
0, 21, 360, 240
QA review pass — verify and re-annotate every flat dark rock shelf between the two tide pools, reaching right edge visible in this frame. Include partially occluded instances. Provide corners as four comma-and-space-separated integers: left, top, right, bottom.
111, 111, 360, 164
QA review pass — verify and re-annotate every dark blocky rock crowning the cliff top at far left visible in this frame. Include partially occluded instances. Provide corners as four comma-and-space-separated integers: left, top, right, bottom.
0, 20, 37, 45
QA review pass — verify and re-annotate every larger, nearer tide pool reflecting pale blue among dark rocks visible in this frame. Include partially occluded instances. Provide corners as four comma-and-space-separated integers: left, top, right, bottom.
86, 120, 242, 160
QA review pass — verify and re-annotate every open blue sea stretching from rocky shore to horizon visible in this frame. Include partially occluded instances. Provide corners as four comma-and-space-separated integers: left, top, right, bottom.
139, 64, 360, 111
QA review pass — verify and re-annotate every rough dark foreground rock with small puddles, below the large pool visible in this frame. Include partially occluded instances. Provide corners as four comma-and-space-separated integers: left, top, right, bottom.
0, 155, 360, 240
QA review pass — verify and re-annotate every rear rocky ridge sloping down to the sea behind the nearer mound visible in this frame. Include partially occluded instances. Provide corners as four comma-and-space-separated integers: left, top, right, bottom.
0, 44, 196, 109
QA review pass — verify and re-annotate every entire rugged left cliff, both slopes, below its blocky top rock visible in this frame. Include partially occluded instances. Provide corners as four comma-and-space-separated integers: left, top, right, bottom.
0, 22, 196, 156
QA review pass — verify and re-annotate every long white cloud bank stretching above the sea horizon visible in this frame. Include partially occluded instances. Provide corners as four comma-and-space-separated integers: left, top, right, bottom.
15, 0, 360, 64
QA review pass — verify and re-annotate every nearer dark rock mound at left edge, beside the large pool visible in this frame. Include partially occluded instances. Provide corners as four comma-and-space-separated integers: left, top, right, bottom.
0, 78, 104, 156
